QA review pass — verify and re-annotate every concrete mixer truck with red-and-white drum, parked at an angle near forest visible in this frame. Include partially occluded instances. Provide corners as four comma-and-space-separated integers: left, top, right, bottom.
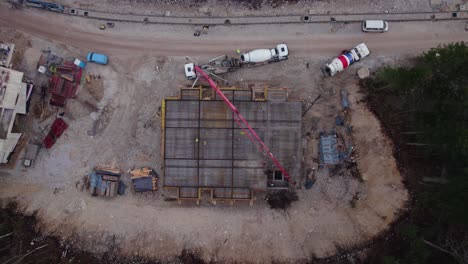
325, 43, 370, 76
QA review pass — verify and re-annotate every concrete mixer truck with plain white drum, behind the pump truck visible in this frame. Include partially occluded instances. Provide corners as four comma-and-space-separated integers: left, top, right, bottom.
240, 43, 289, 66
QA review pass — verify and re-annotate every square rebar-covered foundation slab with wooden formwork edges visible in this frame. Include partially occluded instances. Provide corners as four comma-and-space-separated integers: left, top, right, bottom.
162, 87, 302, 204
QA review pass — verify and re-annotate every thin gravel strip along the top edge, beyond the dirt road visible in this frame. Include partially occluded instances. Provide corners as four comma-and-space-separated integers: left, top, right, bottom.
62, 0, 438, 16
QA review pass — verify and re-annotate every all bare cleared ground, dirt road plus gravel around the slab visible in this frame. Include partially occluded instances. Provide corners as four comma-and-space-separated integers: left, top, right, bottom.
0, 3, 468, 262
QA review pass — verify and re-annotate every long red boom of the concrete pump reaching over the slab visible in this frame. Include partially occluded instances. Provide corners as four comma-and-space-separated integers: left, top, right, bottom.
194, 65, 295, 184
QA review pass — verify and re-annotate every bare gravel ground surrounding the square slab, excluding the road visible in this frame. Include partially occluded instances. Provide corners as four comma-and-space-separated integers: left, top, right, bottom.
0, 26, 407, 263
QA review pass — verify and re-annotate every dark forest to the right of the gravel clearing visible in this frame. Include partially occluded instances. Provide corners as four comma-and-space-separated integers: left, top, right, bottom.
361, 42, 468, 264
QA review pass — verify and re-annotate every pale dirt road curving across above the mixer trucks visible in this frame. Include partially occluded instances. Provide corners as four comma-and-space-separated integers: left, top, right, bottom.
0, 6, 468, 56
